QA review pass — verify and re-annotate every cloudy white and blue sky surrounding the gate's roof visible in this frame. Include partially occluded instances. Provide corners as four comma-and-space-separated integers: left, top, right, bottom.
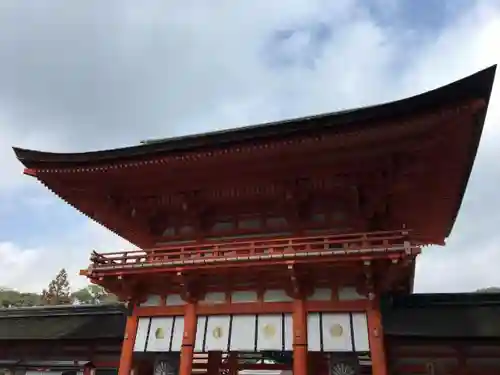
0, 0, 500, 292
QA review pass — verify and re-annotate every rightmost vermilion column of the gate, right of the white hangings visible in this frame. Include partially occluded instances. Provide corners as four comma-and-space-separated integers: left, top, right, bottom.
367, 303, 388, 375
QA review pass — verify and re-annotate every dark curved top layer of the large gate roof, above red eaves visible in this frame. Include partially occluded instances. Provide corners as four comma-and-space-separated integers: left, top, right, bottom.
14, 65, 496, 168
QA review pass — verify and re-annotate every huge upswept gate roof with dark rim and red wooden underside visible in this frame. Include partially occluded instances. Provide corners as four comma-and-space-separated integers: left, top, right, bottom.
15, 67, 495, 248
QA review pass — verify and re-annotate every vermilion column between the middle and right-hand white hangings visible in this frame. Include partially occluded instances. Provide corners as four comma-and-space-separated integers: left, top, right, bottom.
293, 299, 307, 375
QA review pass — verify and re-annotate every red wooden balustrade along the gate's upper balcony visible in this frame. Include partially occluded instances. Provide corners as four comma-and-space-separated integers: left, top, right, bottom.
90, 230, 412, 270
